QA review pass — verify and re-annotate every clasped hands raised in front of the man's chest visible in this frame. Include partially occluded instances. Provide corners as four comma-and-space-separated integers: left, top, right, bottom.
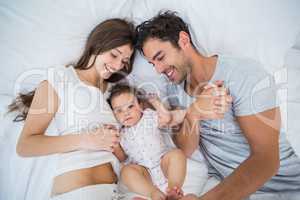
187, 81, 232, 120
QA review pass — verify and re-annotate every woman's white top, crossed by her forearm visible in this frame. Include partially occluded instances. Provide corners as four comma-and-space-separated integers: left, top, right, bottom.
47, 66, 119, 175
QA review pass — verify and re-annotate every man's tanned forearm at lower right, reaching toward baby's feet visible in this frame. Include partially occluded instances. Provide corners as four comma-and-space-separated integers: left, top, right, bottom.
200, 155, 279, 200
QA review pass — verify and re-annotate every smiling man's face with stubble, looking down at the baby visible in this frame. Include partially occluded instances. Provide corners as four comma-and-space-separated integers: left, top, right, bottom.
143, 38, 190, 84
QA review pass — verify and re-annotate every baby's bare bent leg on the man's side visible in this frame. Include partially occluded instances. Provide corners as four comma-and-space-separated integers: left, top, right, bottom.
160, 149, 186, 198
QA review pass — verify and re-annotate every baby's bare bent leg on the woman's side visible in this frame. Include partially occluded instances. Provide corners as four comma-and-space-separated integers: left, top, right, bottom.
121, 164, 165, 199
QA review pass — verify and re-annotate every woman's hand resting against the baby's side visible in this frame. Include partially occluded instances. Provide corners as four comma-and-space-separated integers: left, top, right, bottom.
81, 125, 120, 152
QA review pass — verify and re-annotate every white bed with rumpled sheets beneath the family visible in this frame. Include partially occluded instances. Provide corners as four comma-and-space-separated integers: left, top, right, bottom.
0, 0, 300, 200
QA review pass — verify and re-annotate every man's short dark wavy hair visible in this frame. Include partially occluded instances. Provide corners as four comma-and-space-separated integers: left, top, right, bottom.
136, 10, 190, 53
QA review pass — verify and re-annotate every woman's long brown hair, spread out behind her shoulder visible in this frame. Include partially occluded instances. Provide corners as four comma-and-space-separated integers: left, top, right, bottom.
8, 18, 135, 122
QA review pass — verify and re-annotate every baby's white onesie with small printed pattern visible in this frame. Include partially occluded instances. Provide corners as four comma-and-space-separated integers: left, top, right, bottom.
120, 109, 170, 168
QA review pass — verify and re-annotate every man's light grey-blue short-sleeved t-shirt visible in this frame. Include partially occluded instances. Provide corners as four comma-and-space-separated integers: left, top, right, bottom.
167, 56, 300, 192
